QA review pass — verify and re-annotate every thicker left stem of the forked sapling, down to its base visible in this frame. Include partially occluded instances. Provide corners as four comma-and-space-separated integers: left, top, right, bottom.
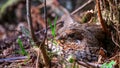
26, 0, 50, 67
